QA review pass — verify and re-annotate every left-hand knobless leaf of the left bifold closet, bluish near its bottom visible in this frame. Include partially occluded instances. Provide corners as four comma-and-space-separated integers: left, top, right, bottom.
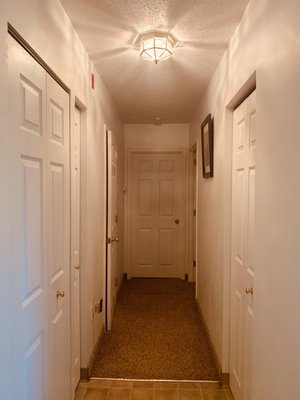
8, 37, 48, 400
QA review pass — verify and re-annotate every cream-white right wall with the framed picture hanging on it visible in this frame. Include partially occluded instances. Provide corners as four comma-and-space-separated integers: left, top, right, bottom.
190, 0, 300, 400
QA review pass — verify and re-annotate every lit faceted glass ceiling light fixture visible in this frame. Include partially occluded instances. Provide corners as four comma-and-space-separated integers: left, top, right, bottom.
139, 32, 175, 64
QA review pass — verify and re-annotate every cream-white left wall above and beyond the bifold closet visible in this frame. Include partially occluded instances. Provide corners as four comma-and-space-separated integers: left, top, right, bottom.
0, 0, 123, 384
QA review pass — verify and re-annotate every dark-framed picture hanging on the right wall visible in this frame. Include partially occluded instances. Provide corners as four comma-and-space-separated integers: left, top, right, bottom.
201, 114, 214, 178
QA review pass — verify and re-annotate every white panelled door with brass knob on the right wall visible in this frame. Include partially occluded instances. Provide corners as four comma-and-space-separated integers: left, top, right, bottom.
230, 92, 256, 400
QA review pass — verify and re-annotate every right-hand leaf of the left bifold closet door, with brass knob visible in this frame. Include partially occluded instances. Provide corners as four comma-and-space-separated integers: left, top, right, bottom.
47, 75, 70, 400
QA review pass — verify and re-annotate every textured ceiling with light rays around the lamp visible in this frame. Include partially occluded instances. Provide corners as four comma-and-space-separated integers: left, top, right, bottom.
61, 0, 248, 123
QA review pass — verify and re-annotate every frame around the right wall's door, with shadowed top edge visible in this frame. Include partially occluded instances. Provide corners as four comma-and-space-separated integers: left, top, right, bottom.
220, 71, 256, 376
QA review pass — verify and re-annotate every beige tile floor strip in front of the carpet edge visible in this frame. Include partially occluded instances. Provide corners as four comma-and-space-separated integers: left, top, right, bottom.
75, 379, 233, 400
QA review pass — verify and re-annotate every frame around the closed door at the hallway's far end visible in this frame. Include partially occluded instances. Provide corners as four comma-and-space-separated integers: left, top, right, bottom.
123, 148, 189, 277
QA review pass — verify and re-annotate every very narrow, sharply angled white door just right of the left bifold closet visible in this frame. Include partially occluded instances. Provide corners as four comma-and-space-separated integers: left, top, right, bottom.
71, 107, 81, 393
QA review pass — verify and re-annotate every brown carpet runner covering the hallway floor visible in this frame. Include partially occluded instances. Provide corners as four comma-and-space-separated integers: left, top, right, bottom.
92, 279, 218, 380
